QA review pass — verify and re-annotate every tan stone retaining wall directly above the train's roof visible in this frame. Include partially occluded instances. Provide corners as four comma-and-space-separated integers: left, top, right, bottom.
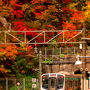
45, 64, 81, 73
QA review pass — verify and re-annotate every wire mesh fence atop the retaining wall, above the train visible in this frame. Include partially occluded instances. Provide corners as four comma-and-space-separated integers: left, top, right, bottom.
42, 47, 90, 60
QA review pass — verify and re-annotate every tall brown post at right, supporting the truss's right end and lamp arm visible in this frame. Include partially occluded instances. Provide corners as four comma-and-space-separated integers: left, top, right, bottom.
82, 25, 86, 90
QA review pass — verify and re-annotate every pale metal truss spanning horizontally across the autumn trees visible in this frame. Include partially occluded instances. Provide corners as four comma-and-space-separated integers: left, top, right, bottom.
0, 30, 86, 44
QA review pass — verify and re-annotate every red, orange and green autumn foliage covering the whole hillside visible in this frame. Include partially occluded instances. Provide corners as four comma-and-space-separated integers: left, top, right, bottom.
0, 0, 90, 76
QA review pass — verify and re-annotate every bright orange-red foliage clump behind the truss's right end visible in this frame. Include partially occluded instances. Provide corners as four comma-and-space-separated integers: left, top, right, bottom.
58, 22, 78, 47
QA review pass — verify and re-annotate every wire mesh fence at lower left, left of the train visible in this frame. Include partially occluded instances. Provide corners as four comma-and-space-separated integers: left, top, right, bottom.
0, 78, 39, 90
